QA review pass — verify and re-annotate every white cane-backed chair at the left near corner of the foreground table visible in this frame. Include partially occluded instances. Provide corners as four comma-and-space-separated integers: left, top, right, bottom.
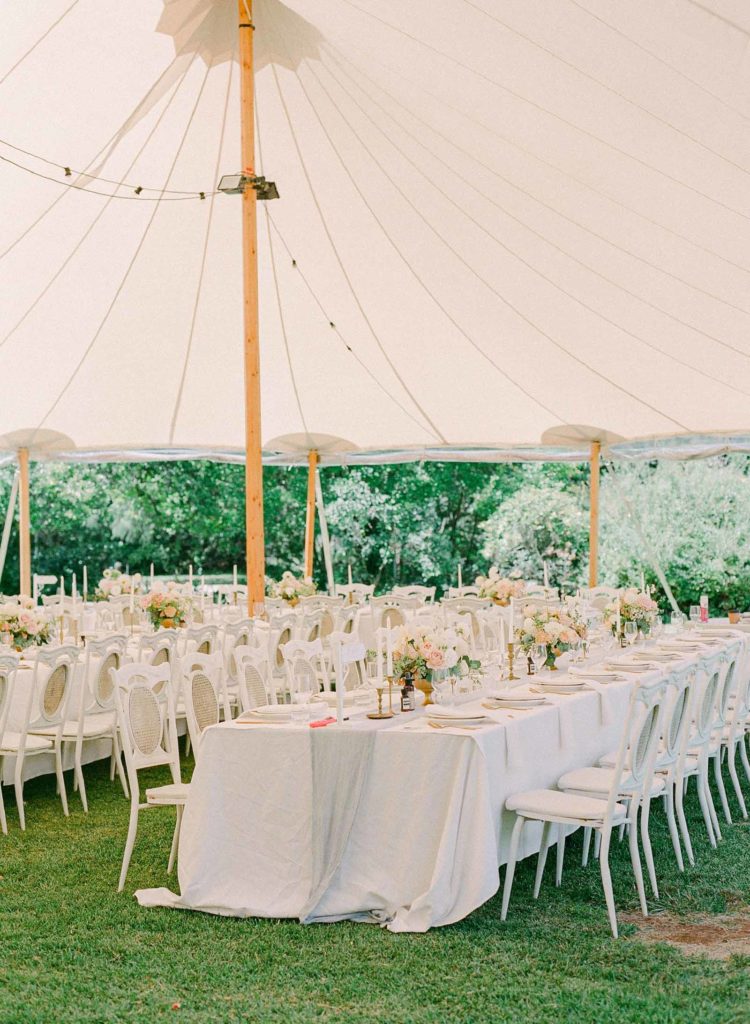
113, 663, 190, 892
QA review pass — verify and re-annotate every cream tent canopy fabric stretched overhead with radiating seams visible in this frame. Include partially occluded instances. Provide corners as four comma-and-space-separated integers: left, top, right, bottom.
0, 0, 750, 462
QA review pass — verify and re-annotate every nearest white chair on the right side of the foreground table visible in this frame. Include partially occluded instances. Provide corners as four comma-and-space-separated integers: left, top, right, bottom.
501, 680, 667, 938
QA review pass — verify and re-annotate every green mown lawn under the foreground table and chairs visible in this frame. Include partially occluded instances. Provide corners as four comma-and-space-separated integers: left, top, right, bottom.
0, 765, 750, 1024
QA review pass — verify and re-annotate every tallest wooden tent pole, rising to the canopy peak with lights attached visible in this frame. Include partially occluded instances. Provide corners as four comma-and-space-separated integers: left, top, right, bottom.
238, 0, 265, 614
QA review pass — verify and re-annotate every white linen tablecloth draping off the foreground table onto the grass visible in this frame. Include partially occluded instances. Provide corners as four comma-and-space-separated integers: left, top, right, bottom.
136, 682, 629, 932
